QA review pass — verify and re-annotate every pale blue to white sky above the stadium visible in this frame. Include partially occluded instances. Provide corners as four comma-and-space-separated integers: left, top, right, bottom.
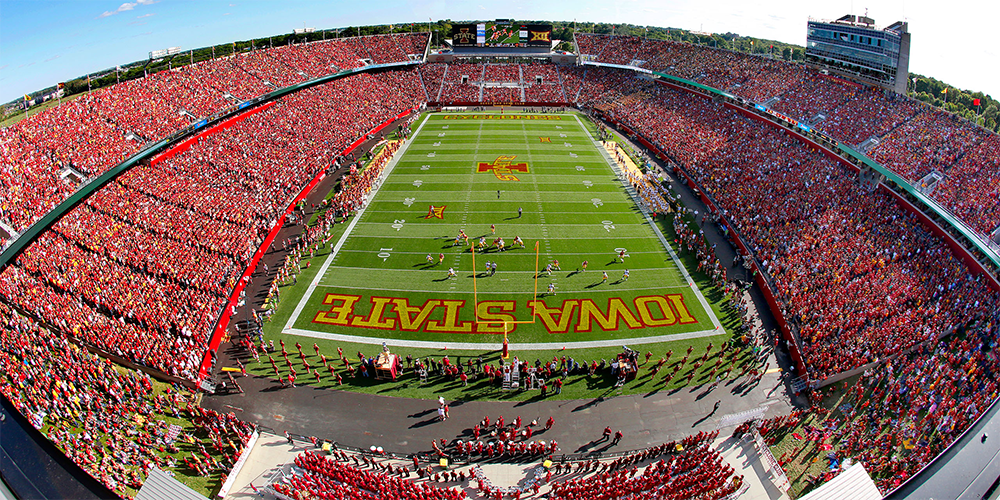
0, 0, 1000, 102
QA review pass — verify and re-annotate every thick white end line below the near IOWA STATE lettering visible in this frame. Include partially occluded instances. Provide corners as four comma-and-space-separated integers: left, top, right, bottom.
283, 328, 720, 351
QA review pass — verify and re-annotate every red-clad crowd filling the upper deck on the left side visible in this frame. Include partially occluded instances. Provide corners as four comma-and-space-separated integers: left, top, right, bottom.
0, 33, 428, 236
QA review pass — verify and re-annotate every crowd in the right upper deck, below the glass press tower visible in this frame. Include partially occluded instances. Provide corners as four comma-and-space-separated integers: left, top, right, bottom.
566, 33, 1000, 239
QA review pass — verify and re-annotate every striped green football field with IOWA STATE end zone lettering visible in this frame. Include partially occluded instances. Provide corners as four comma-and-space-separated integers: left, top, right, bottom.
283, 113, 723, 349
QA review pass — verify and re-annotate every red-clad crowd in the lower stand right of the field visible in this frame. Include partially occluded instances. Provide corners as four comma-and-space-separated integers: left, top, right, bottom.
584, 74, 997, 378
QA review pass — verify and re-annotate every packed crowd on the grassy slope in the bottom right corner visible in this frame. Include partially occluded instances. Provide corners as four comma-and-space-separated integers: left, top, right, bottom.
752, 304, 1000, 493
